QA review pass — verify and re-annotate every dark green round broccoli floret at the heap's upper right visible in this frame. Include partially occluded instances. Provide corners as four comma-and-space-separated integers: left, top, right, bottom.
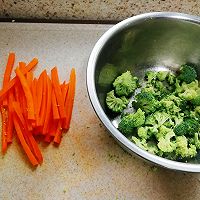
178, 65, 197, 83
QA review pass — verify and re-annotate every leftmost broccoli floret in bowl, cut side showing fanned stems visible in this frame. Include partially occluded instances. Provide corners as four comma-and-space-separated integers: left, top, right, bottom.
106, 90, 129, 113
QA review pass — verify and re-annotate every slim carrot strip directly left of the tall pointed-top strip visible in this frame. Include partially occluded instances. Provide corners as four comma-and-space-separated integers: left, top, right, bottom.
43, 76, 52, 134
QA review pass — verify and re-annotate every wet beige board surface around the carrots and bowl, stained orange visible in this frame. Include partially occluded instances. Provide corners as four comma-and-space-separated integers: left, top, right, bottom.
0, 23, 200, 200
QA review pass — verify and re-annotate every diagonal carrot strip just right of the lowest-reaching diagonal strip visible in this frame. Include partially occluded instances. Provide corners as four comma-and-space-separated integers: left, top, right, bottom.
13, 102, 43, 164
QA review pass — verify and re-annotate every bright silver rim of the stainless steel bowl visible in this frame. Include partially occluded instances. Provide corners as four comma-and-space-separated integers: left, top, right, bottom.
86, 12, 200, 172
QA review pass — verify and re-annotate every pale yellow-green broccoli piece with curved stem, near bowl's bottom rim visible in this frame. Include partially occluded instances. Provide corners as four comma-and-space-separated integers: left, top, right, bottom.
158, 130, 176, 153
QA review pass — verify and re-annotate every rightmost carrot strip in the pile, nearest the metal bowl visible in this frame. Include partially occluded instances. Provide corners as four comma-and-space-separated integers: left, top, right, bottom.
63, 68, 76, 129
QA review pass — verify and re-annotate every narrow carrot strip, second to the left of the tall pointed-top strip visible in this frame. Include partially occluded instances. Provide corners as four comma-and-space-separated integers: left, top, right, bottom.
39, 70, 47, 126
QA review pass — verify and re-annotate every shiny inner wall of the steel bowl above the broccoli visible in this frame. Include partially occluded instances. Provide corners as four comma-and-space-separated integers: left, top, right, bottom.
95, 18, 200, 163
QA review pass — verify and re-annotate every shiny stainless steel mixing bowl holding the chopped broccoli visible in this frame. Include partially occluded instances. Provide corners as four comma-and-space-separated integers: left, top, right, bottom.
87, 12, 200, 172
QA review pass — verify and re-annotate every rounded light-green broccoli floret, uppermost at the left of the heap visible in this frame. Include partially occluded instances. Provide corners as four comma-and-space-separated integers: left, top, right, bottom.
113, 71, 138, 97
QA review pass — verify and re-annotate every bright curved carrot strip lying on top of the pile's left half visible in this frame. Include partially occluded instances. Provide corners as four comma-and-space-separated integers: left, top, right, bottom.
15, 68, 35, 120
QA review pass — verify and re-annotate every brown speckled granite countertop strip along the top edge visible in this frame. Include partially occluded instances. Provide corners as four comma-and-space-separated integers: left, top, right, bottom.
0, 0, 200, 20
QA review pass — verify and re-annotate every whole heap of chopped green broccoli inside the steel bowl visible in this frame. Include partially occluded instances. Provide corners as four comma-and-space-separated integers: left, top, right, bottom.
106, 65, 200, 161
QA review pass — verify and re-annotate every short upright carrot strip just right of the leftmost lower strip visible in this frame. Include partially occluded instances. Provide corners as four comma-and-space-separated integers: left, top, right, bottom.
7, 90, 15, 143
